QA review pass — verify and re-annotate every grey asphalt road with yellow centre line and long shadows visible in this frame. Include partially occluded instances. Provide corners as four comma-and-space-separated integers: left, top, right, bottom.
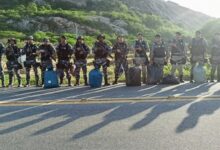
0, 83, 220, 150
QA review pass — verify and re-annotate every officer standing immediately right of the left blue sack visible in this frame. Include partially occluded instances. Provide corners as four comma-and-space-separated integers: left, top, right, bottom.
56, 36, 73, 86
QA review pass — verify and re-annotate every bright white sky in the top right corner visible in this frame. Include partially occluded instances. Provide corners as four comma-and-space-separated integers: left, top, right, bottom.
167, 0, 220, 18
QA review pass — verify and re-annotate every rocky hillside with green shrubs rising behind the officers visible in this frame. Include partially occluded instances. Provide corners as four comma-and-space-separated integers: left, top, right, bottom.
0, 0, 212, 44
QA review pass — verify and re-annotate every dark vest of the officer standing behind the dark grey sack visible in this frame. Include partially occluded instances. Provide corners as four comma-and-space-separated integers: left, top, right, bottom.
153, 42, 166, 58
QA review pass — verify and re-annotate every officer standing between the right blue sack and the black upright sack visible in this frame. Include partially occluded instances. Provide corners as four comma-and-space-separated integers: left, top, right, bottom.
112, 36, 129, 84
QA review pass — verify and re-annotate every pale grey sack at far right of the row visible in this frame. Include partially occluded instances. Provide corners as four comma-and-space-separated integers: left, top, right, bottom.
193, 64, 207, 83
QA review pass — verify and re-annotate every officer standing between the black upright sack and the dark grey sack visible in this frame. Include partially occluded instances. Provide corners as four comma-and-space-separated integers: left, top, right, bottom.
134, 33, 149, 83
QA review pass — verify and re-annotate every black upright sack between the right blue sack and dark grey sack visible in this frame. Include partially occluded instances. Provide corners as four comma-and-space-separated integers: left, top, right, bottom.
126, 67, 141, 86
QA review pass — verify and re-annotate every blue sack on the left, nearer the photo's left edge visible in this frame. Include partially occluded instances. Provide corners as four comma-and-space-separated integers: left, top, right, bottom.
44, 70, 59, 88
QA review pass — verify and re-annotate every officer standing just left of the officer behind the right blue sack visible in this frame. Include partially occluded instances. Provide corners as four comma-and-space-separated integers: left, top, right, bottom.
74, 36, 90, 86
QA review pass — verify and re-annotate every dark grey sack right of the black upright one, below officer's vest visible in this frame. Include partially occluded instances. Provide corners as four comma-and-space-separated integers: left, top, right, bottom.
147, 64, 163, 84
